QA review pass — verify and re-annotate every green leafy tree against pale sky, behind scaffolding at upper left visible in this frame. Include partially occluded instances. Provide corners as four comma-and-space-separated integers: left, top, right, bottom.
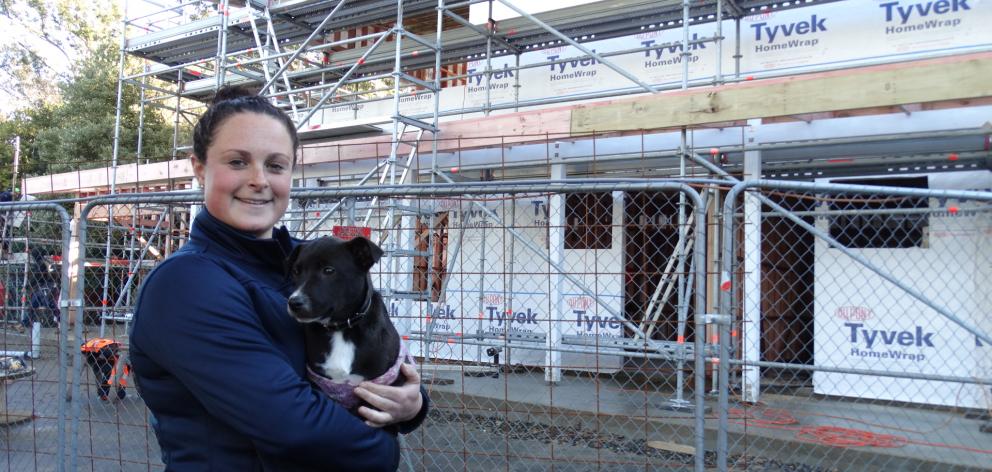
0, 0, 178, 183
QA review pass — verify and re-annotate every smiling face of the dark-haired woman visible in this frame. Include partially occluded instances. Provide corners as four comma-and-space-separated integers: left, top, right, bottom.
192, 113, 293, 238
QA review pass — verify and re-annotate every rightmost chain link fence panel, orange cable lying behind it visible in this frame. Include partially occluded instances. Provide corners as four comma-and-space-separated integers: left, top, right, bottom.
717, 180, 992, 471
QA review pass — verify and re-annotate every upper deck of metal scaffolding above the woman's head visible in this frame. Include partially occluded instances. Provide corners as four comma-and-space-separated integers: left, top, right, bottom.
114, 0, 860, 160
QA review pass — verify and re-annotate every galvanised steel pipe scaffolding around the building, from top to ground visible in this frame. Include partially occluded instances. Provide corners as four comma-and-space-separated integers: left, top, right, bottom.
75, 0, 986, 408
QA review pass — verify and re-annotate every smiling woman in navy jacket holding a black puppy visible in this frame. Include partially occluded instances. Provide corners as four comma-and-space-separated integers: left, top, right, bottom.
130, 89, 427, 471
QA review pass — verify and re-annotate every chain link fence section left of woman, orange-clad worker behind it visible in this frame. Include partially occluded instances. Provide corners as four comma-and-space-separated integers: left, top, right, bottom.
70, 199, 190, 470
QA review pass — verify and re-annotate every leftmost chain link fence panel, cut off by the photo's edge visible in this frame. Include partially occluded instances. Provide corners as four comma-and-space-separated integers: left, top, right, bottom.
0, 202, 72, 470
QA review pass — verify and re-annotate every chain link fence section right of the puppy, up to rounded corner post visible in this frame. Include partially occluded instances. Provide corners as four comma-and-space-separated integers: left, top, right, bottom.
297, 183, 702, 471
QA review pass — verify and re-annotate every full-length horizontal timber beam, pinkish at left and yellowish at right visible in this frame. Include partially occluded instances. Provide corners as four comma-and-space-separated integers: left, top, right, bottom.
24, 53, 992, 195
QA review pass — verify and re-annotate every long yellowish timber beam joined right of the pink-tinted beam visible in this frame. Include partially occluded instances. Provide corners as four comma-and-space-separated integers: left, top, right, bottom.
571, 53, 992, 133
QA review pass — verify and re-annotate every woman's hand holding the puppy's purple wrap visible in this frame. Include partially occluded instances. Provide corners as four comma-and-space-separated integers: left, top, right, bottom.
355, 363, 424, 428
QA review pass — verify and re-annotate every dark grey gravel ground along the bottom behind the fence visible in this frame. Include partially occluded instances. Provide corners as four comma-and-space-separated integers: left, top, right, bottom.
0, 327, 976, 472
